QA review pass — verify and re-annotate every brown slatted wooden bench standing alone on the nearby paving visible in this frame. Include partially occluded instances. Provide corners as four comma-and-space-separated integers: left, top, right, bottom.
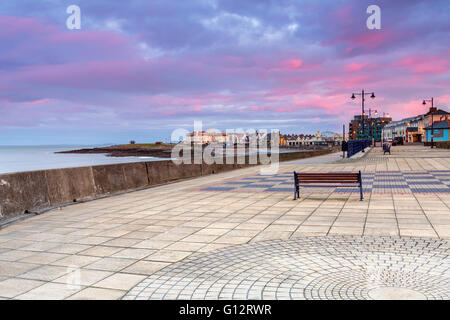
294, 171, 363, 201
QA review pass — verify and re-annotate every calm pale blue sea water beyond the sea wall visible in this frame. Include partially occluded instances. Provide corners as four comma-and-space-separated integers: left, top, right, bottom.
0, 146, 167, 174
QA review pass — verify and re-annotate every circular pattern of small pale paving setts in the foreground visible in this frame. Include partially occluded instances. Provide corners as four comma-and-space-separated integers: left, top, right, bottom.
124, 236, 450, 299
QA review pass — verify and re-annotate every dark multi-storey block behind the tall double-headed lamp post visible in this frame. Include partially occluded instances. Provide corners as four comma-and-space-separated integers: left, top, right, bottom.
348, 115, 392, 141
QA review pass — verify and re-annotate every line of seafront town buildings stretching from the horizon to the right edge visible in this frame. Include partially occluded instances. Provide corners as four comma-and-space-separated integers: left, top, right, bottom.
185, 107, 450, 148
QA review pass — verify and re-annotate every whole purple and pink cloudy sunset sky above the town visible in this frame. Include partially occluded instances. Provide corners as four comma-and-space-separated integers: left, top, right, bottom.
0, 0, 450, 145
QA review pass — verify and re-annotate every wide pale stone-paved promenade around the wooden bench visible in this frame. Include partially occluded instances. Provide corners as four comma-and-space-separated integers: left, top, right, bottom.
0, 145, 450, 299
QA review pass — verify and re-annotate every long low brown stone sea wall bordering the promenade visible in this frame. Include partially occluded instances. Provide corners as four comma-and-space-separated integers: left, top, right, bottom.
0, 149, 335, 220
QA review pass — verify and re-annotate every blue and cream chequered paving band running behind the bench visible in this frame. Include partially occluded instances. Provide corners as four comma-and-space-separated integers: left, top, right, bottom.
200, 170, 450, 194
